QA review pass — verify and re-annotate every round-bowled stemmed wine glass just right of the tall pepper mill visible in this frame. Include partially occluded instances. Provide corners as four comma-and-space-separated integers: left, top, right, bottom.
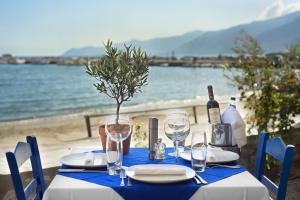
164, 115, 190, 161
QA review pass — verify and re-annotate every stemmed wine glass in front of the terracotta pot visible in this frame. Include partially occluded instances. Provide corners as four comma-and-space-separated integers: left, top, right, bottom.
105, 119, 131, 169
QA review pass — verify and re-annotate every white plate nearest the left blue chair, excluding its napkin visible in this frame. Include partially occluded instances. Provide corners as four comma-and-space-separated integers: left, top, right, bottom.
60, 153, 106, 168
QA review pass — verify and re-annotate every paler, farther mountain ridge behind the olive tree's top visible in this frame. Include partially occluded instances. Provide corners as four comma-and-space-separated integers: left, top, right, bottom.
63, 31, 203, 57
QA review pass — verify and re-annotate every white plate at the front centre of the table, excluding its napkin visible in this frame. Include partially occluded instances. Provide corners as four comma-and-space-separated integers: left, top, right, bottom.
126, 164, 195, 183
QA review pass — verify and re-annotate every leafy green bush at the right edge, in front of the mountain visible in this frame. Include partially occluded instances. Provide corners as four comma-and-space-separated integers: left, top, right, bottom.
226, 31, 300, 136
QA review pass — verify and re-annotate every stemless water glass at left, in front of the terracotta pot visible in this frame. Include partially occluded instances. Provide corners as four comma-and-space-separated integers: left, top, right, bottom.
106, 135, 123, 175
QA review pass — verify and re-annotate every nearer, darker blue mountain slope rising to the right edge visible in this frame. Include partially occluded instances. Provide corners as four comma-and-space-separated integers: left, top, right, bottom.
175, 12, 300, 56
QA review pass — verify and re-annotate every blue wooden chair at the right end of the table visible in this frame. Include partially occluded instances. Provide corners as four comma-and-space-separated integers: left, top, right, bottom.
255, 132, 295, 200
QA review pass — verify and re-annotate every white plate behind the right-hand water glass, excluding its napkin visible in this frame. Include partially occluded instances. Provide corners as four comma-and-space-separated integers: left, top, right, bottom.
180, 148, 240, 163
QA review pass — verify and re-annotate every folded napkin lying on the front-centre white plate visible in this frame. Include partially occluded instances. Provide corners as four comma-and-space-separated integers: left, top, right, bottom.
134, 166, 186, 175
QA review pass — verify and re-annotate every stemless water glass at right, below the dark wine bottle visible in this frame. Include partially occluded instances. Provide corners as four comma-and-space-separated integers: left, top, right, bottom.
191, 131, 207, 172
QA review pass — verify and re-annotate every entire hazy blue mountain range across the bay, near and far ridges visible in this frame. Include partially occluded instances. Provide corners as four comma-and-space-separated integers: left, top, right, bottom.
63, 12, 300, 56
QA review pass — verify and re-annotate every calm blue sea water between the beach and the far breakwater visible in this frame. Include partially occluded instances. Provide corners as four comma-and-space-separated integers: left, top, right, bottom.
0, 65, 237, 120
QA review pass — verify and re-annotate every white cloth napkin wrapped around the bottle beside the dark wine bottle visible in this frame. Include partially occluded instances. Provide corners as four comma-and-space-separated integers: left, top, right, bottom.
222, 106, 247, 148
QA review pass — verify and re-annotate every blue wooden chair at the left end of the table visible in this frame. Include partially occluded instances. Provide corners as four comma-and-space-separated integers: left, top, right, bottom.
6, 136, 46, 200
